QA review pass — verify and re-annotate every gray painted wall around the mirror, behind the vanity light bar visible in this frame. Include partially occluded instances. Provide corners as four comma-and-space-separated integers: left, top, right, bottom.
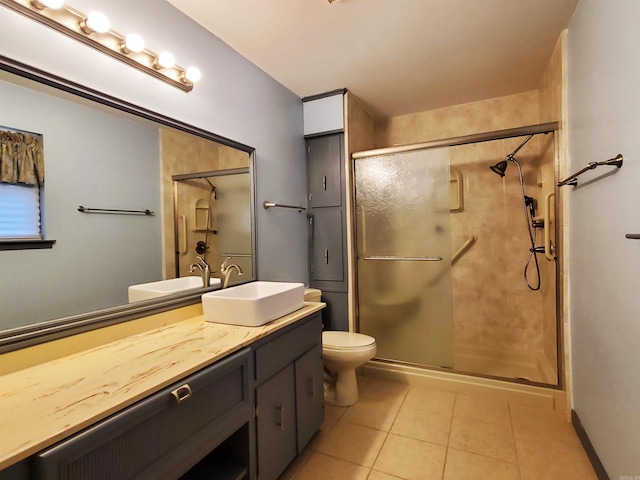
0, 0, 307, 328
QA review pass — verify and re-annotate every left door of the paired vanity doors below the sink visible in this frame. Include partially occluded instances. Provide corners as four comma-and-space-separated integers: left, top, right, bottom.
256, 365, 297, 480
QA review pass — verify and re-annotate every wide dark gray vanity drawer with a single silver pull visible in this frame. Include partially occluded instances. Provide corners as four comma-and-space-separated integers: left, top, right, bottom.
34, 349, 252, 480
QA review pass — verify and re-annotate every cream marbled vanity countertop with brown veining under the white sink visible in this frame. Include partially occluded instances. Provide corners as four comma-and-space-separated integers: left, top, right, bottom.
0, 302, 325, 470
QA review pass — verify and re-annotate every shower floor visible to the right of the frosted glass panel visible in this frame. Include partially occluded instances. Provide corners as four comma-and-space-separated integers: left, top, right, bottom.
454, 345, 557, 385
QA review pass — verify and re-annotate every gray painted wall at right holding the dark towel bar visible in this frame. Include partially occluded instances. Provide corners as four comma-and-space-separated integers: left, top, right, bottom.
564, 0, 640, 479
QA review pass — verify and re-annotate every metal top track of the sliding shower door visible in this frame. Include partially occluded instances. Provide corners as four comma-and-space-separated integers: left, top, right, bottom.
351, 122, 559, 160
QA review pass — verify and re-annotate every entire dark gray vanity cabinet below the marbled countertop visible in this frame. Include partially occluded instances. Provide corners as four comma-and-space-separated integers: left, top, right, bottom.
0, 312, 324, 480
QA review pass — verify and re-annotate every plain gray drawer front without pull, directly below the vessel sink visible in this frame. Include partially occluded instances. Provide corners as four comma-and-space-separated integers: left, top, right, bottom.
255, 313, 322, 384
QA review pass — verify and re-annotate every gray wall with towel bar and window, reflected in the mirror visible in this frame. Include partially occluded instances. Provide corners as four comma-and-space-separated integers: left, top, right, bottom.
0, 81, 162, 329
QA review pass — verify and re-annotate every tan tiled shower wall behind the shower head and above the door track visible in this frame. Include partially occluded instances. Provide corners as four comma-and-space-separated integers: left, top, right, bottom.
378, 73, 557, 378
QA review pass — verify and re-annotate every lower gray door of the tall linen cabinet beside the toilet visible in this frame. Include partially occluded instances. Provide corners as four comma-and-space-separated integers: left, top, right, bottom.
311, 208, 344, 282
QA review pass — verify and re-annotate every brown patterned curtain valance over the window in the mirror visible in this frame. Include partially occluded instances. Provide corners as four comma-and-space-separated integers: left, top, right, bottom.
0, 129, 44, 186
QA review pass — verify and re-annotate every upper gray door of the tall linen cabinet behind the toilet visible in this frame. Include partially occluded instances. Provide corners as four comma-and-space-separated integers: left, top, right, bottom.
306, 134, 343, 208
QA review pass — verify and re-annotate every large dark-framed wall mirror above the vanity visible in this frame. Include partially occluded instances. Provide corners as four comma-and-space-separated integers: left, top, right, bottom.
0, 58, 256, 349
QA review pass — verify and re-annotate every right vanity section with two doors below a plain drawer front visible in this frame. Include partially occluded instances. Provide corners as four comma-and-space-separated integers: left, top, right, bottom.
255, 314, 324, 480
